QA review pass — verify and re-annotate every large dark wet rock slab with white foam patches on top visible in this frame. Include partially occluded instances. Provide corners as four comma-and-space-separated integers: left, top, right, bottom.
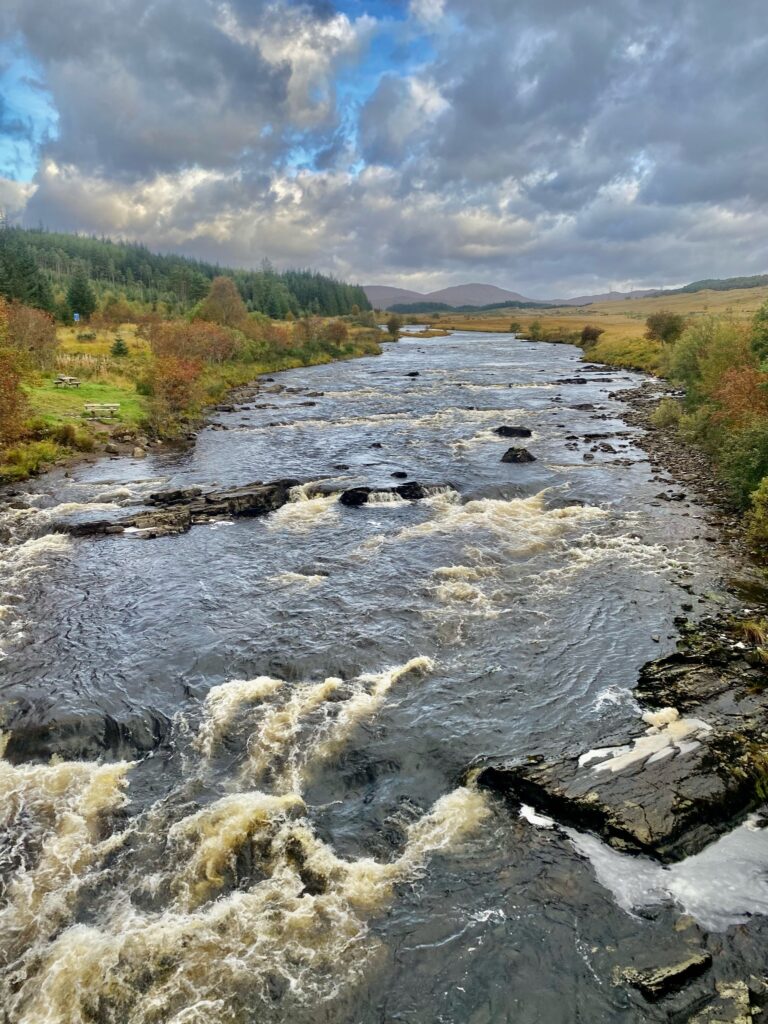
475, 623, 768, 862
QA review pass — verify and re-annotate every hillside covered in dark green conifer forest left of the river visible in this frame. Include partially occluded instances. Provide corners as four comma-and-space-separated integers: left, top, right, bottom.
0, 227, 370, 319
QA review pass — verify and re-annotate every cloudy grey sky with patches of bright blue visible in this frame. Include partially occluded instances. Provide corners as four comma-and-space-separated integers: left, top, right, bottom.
0, 0, 768, 298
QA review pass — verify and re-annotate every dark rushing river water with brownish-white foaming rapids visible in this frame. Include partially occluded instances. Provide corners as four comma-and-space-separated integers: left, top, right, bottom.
0, 334, 768, 1024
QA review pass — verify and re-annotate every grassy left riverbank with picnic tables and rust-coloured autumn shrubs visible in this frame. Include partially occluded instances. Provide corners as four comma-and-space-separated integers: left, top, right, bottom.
0, 317, 381, 482
